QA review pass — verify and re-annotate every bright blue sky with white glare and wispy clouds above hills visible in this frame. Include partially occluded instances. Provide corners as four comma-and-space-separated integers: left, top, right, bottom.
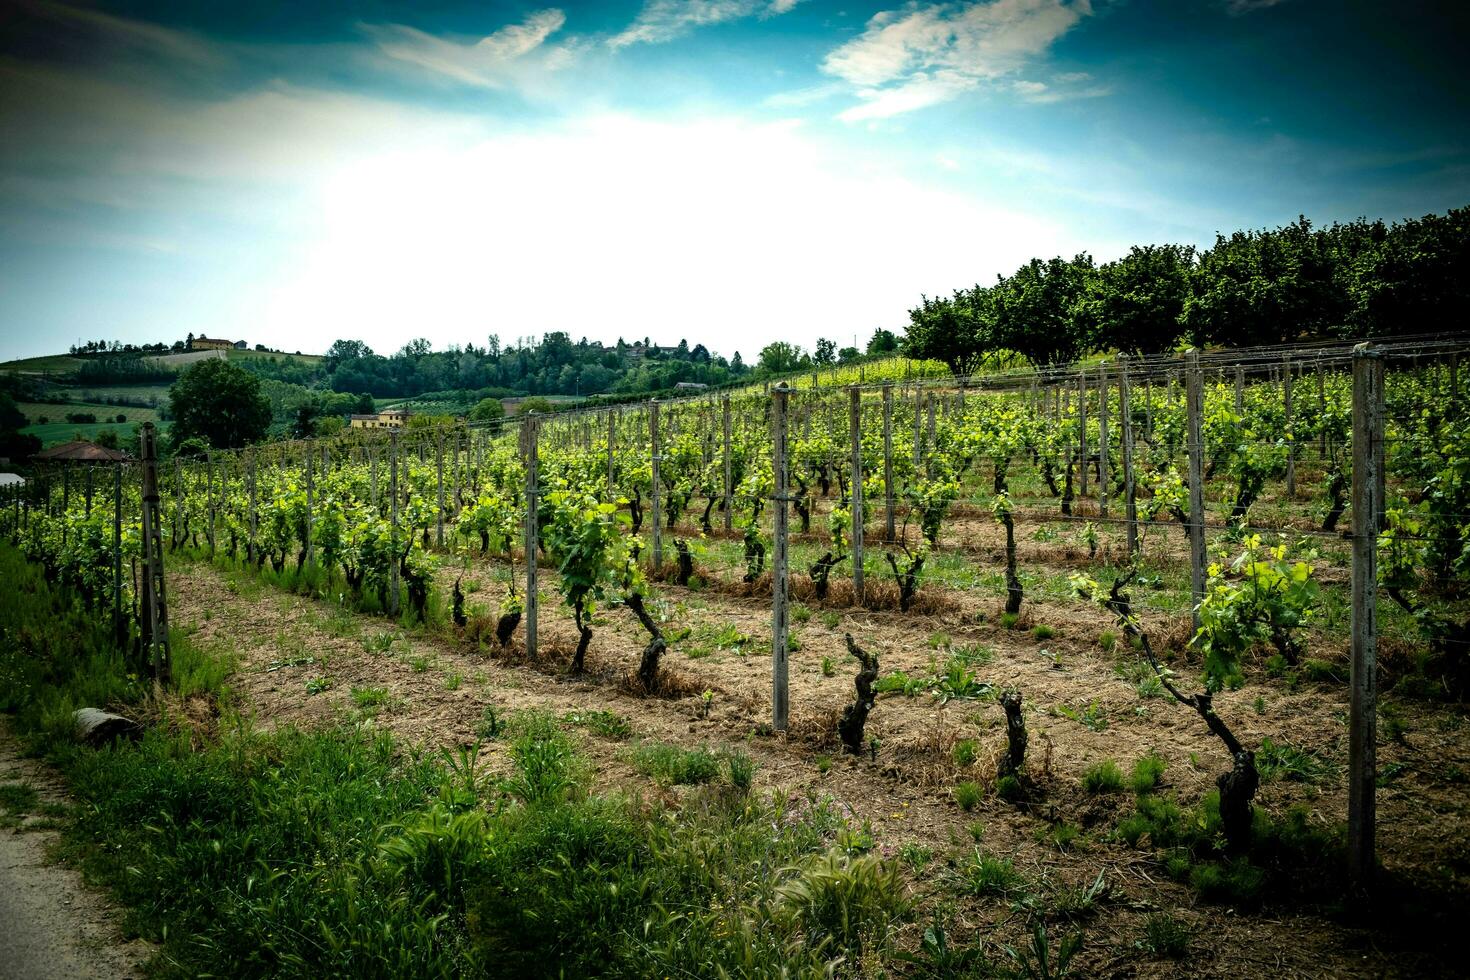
0, 0, 1470, 359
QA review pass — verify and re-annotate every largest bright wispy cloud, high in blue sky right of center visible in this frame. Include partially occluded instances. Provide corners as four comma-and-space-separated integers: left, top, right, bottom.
822, 0, 1092, 122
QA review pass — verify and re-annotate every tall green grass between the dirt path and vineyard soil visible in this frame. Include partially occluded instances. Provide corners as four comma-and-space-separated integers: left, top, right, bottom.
0, 545, 907, 977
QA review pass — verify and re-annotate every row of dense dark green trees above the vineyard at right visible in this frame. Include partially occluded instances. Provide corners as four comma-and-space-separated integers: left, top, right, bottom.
904, 209, 1470, 375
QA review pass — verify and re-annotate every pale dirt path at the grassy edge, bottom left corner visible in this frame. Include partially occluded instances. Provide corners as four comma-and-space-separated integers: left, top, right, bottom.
0, 723, 153, 980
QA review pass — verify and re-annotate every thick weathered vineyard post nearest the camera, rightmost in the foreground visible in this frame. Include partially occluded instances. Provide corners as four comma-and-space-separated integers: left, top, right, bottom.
1348, 344, 1383, 887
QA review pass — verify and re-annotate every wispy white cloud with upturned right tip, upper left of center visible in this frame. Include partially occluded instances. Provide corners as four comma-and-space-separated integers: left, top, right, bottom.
363, 7, 566, 88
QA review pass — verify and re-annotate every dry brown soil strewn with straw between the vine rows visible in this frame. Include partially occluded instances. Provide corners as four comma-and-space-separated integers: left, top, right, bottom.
169, 537, 1470, 979
